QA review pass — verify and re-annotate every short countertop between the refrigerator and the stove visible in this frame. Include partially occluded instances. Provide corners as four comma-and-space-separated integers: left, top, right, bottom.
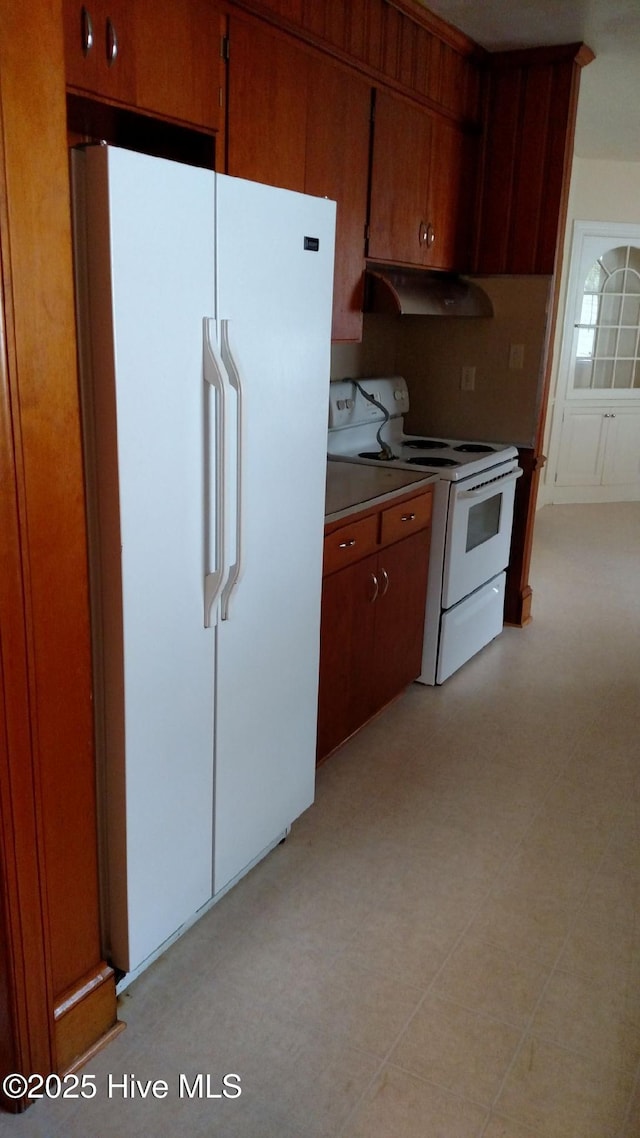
325, 459, 437, 522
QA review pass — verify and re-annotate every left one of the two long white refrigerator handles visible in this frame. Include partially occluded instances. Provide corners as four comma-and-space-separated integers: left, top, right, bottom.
203, 316, 229, 628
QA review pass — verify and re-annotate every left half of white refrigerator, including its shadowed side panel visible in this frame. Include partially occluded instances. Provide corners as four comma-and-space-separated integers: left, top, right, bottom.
74, 147, 215, 971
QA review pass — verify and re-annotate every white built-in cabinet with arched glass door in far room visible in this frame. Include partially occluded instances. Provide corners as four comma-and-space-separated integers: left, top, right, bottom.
547, 222, 640, 502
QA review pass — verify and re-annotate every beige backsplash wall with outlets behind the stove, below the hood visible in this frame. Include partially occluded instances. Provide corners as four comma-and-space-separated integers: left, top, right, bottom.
331, 277, 550, 446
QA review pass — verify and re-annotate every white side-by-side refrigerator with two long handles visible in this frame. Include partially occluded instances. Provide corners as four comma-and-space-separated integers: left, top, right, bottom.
72, 146, 335, 972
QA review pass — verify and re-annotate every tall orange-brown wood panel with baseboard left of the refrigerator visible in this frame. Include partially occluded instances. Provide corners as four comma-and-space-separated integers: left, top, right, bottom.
0, 0, 117, 1111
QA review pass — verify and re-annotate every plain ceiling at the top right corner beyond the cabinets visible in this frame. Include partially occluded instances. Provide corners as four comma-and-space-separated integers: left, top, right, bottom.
421, 0, 640, 162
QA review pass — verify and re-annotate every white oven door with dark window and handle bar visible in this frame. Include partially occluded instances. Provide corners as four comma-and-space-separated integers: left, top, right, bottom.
442, 463, 522, 609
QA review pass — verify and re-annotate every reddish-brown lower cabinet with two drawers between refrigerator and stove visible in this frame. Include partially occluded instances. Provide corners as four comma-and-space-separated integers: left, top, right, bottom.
318, 489, 432, 761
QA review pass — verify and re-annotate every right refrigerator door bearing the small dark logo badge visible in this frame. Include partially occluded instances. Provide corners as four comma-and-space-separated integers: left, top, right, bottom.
214, 175, 335, 892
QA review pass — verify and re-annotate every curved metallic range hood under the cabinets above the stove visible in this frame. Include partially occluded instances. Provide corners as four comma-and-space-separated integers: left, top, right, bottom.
364, 263, 493, 316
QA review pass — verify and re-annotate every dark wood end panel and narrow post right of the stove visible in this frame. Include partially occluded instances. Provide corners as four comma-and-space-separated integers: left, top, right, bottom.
476, 43, 593, 626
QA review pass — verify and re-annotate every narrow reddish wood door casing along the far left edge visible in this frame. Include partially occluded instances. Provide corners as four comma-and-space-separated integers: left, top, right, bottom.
0, 166, 55, 1111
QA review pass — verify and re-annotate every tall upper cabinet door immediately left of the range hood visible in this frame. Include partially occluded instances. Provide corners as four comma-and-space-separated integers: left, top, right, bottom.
304, 56, 371, 340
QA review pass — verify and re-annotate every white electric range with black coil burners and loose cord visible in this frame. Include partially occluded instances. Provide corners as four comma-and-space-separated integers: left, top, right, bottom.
328, 376, 522, 684
